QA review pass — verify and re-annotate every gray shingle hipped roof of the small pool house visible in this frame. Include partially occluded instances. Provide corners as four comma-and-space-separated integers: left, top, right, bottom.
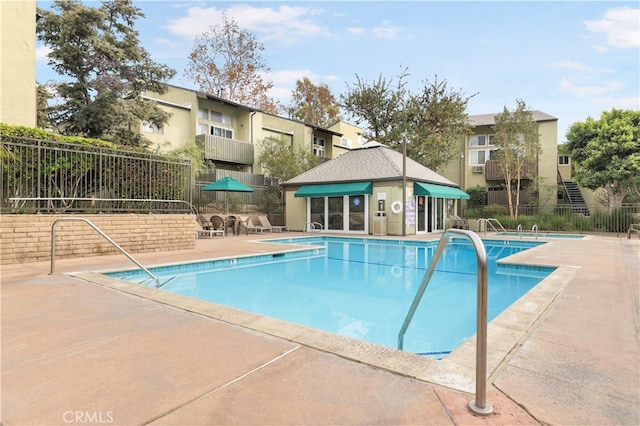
283, 145, 458, 188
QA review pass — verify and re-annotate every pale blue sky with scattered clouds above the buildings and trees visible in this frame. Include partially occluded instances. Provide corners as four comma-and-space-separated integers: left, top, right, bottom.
36, 0, 640, 143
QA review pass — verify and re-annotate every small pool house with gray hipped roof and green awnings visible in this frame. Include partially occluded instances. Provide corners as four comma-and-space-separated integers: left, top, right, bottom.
282, 142, 469, 235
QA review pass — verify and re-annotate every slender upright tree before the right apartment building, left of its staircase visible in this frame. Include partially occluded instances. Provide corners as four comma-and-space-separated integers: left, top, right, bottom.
492, 100, 542, 219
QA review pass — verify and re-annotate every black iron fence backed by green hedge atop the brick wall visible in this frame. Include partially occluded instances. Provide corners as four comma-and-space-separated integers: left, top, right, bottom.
0, 136, 193, 214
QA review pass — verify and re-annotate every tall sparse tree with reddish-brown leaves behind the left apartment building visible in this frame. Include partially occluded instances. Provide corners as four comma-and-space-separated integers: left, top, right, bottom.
185, 15, 279, 114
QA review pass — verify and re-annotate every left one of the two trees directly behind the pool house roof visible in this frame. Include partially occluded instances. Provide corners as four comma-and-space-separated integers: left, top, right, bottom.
340, 70, 408, 147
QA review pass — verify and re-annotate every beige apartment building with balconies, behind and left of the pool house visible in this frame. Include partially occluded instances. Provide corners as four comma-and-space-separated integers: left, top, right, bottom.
141, 85, 362, 174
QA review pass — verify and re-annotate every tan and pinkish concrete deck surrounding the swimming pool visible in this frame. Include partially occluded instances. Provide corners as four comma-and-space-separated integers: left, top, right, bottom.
1, 232, 640, 425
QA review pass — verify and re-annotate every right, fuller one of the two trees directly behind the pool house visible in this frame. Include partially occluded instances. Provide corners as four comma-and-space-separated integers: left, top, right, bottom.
405, 76, 475, 170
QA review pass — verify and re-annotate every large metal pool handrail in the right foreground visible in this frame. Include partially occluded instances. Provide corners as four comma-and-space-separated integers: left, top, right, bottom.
398, 228, 493, 415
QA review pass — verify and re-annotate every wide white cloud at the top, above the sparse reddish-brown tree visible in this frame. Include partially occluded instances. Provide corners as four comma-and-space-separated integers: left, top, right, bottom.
167, 4, 330, 43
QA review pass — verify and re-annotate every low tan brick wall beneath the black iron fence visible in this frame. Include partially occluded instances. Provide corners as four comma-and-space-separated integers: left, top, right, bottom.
0, 214, 195, 265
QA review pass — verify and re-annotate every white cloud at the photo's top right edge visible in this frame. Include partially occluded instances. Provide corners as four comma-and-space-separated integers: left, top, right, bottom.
585, 7, 640, 51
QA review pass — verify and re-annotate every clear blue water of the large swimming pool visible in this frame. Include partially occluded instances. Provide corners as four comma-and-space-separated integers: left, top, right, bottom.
108, 237, 554, 357
